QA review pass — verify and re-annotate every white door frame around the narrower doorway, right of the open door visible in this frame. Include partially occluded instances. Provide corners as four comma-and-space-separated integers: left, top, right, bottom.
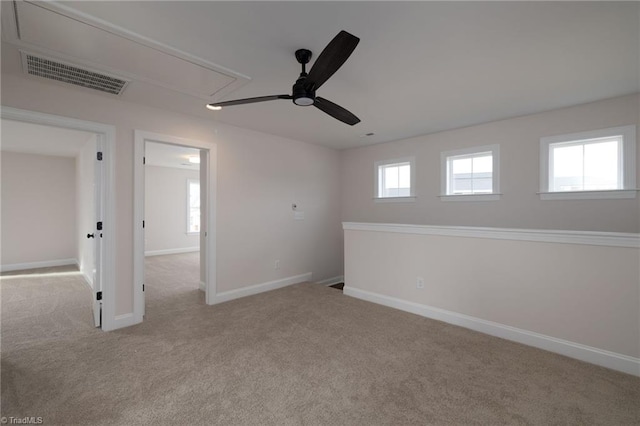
133, 130, 218, 322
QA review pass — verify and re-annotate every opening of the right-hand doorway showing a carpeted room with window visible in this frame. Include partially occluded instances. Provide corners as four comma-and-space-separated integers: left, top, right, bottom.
144, 141, 204, 312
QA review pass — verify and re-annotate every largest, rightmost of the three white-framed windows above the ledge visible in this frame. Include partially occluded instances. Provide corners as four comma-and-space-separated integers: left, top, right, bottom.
540, 126, 635, 199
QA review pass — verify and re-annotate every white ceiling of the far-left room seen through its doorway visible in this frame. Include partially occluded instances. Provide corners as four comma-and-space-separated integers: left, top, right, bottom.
0, 119, 95, 157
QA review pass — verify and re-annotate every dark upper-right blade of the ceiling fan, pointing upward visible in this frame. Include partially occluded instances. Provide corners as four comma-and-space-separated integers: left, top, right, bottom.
305, 31, 360, 90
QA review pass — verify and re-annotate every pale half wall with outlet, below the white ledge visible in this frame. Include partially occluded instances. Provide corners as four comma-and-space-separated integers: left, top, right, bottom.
345, 227, 640, 360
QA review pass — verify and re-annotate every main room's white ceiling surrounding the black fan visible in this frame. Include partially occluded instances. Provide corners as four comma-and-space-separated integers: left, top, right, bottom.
2, 1, 640, 149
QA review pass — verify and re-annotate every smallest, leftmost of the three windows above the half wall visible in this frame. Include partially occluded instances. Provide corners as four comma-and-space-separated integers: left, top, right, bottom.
375, 158, 415, 201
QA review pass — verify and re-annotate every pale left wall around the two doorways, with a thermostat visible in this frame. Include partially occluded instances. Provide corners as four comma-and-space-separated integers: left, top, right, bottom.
2, 71, 343, 315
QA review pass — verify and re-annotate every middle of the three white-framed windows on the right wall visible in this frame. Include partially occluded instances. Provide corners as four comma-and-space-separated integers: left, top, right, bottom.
441, 145, 500, 201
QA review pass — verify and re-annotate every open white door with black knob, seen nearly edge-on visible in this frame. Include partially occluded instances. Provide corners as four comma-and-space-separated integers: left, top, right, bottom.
92, 140, 104, 327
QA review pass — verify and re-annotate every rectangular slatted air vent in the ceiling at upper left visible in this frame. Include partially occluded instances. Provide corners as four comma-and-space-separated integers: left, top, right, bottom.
22, 52, 128, 95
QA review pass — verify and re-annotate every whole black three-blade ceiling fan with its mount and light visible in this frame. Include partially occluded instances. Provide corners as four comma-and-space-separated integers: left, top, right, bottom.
207, 31, 360, 126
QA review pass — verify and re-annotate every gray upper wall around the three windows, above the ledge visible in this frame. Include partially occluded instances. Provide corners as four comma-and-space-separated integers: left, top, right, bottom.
341, 95, 640, 232
